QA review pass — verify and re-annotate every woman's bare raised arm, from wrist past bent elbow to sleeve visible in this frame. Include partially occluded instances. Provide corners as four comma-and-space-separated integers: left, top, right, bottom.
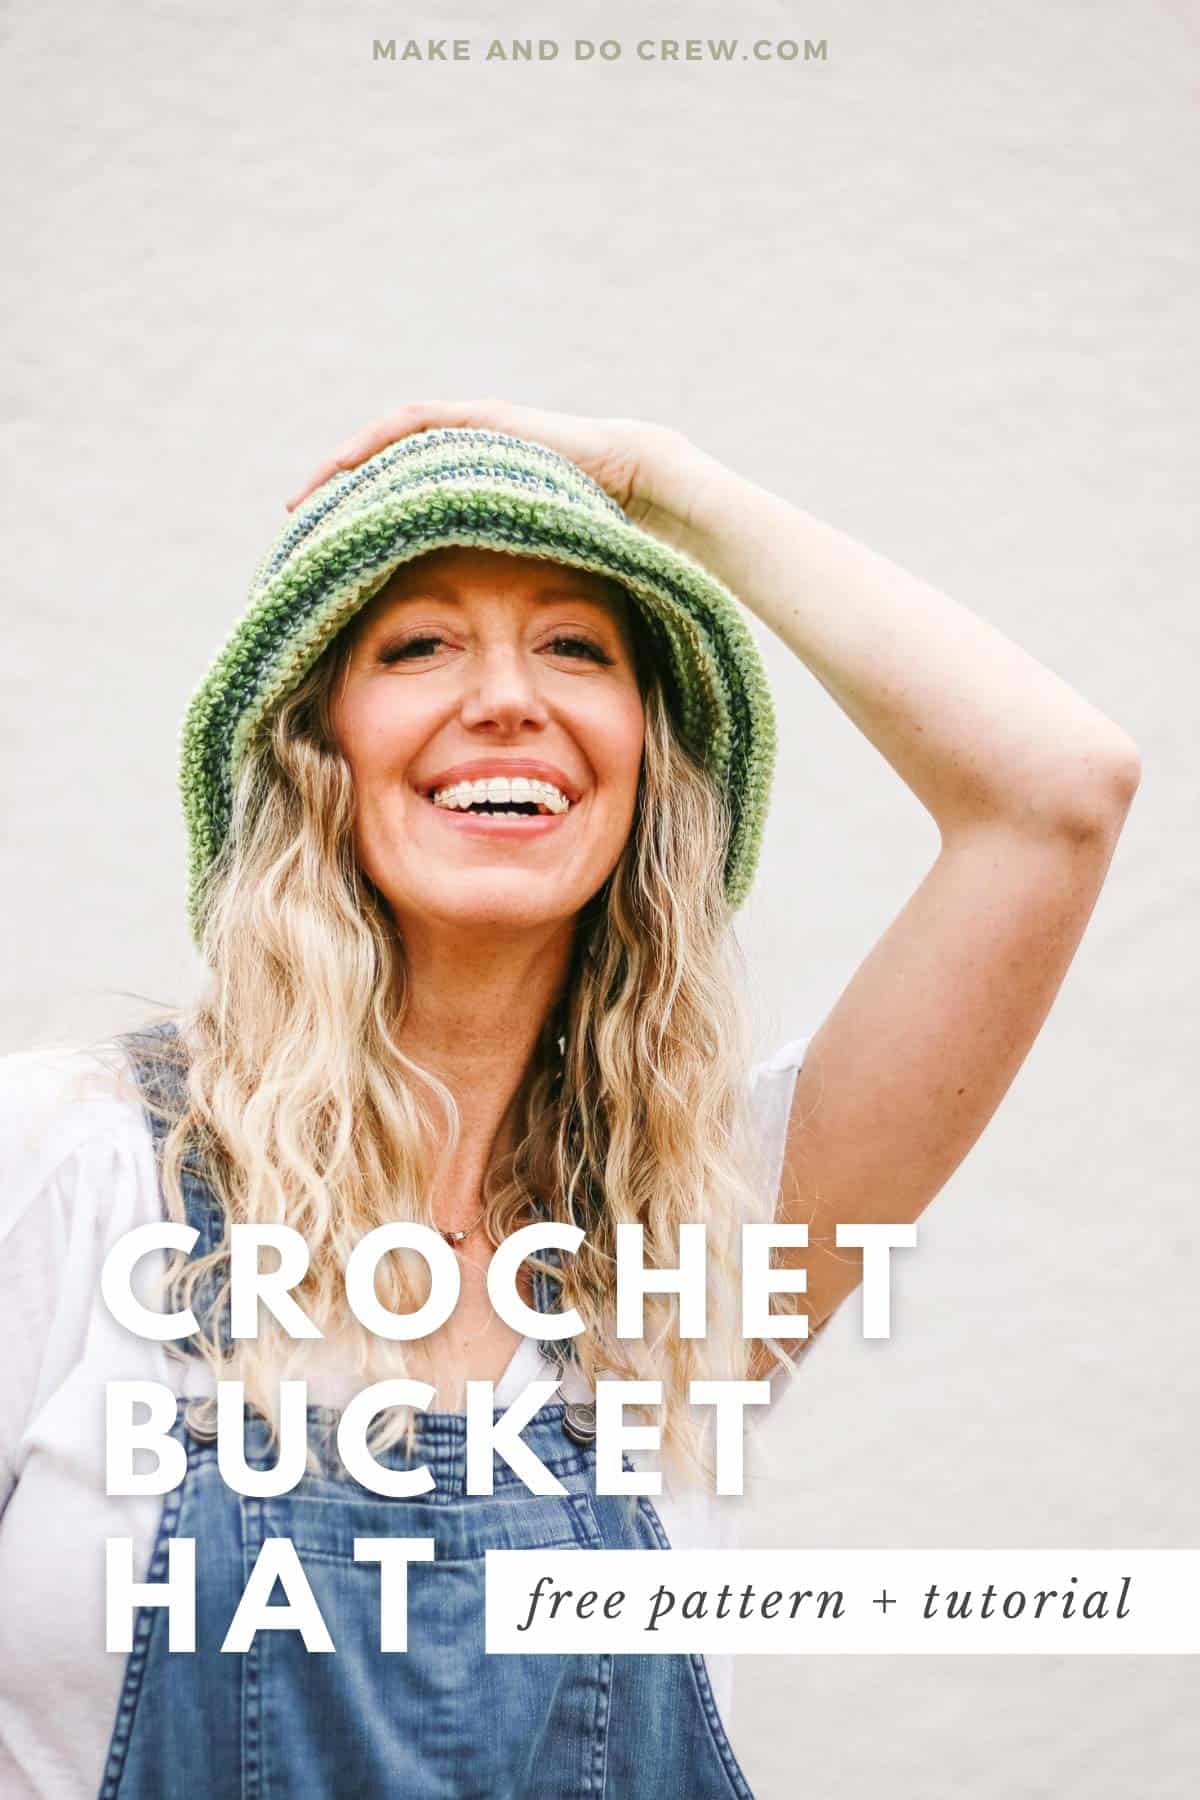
658, 442, 1141, 1370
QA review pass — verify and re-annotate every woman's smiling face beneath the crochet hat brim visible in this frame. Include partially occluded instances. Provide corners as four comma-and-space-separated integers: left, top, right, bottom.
333, 547, 644, 931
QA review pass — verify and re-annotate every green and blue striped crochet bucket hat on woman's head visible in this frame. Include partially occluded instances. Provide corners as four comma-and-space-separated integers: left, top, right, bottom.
180, 428, 775, 941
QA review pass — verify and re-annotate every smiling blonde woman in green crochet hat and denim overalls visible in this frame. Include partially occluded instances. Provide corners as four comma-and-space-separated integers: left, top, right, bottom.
0, 401, 1139, 1796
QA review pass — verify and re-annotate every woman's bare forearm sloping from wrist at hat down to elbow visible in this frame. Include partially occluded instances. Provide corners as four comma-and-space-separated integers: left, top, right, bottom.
648, 446, 1139, 837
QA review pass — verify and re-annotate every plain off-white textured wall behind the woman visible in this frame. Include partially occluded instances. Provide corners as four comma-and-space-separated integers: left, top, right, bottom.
0, 0, 1200, 1800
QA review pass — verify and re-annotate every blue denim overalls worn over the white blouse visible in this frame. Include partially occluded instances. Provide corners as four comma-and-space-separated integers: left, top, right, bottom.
101, 1026, 752, 1800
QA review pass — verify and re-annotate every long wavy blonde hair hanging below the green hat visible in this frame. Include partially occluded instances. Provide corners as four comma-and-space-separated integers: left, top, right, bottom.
141, 576, 786, 1483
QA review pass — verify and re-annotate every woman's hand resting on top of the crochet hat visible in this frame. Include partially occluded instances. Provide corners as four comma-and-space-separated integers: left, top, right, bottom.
286, 400, 689, 517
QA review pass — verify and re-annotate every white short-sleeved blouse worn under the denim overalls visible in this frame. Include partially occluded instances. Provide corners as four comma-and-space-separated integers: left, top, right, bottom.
0, 1039, 806, 1800
